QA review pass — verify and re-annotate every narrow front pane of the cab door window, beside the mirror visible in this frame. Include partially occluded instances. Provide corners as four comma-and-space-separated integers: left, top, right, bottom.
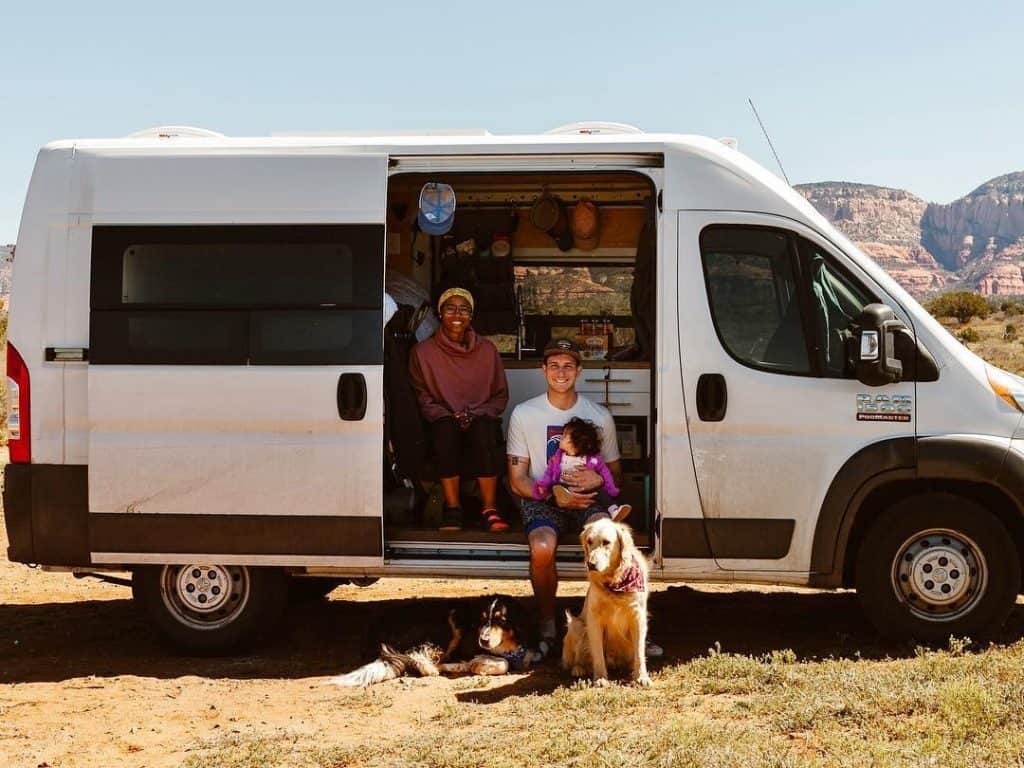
798, 238, 874, 379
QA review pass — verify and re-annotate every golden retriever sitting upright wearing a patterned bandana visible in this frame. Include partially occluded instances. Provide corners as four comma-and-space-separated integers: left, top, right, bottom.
562, 518, 650, 686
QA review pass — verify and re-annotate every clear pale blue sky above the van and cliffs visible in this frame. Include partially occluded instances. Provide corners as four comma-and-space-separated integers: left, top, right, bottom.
0, 0, 1024, 243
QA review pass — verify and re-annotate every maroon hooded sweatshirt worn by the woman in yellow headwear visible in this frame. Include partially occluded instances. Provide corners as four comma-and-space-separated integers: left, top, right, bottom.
409, 328, 509, 422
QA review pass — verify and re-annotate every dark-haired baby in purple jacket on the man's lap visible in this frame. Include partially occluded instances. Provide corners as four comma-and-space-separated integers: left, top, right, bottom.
534, 417, 633, 522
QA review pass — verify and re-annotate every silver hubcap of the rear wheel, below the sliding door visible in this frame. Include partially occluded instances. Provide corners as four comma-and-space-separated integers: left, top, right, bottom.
160, 563, 250, 630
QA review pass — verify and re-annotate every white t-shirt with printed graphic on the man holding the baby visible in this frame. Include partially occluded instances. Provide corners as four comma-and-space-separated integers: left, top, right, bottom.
506, 392, 618, 482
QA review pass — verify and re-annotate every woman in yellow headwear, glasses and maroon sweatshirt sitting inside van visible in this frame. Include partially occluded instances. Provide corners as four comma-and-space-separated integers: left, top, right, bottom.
409, 288, 509, 531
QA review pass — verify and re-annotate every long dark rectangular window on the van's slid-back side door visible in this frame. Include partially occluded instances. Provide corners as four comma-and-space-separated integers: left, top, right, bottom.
89, 224, 384, 365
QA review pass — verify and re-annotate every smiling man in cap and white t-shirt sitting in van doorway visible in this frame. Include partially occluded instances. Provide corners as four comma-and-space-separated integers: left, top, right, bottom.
507, 339, 662, 656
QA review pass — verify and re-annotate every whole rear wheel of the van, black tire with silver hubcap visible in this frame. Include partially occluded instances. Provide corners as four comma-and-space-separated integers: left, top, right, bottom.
132, 563, 288, 653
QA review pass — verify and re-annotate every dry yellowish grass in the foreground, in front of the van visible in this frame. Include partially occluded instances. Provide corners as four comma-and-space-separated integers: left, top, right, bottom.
178, 641, 1024, 768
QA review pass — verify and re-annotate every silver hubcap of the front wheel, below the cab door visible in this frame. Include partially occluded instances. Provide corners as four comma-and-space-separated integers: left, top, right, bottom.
892, 528, 988, 622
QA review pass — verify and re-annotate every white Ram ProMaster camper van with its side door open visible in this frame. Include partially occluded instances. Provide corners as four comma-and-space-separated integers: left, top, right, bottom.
4, 124, 1024, 648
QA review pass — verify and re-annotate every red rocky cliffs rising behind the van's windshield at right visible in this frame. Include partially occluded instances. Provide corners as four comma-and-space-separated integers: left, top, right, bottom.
797, 172, 1024, 296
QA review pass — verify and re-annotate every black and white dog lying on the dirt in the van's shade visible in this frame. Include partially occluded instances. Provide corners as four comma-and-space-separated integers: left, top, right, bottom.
329, 595, 541, 687
